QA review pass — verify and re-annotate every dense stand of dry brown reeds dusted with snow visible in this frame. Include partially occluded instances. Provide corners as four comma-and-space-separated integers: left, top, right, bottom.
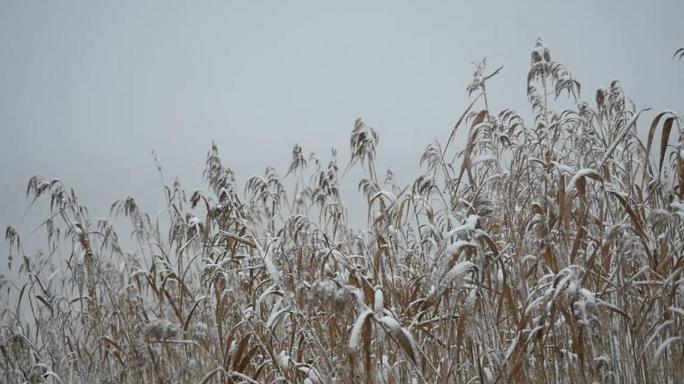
0, 40, 684, 383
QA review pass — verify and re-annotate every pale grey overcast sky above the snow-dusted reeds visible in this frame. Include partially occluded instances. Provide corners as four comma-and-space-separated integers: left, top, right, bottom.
0, 0, 684, 271
